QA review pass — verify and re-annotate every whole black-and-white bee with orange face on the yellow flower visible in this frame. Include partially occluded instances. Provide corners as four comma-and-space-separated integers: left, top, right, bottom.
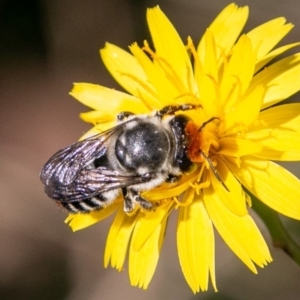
40, 104, 223, 214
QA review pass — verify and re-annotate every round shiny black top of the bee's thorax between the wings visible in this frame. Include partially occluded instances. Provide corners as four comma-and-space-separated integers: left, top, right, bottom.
115, 122, 170, 171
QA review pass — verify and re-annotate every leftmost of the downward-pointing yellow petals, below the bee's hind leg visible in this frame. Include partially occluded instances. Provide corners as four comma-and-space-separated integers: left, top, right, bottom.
104, 207, 136, 271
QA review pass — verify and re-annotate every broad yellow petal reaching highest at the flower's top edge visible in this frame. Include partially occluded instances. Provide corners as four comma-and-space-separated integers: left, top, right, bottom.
198, 3, 249, 58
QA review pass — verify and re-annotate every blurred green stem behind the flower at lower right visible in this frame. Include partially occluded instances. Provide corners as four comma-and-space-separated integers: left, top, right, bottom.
248, 192, 300, 266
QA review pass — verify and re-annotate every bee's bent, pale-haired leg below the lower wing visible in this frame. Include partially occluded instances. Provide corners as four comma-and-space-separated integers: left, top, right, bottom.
122, 188, 153, 213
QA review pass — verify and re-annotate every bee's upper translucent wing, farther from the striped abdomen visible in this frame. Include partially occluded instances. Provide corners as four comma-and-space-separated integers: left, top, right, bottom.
40, 124, 122, 186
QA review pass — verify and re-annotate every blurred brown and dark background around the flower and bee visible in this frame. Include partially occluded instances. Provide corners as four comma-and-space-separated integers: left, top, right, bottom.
0, 0, 300, 300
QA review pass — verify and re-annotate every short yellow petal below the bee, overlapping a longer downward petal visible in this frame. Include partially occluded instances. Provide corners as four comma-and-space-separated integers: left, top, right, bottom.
131, 201, 174, 251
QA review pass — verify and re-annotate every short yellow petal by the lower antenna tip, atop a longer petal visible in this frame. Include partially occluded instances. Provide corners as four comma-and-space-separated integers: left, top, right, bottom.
209, 159, 248, 216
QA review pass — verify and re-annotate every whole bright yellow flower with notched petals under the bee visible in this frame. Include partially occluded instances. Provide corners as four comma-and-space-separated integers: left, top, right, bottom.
66, 4, 300, 292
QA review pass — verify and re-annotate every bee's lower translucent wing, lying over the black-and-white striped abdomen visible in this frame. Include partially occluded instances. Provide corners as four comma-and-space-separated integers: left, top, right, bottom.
45, 168, 153, 202
